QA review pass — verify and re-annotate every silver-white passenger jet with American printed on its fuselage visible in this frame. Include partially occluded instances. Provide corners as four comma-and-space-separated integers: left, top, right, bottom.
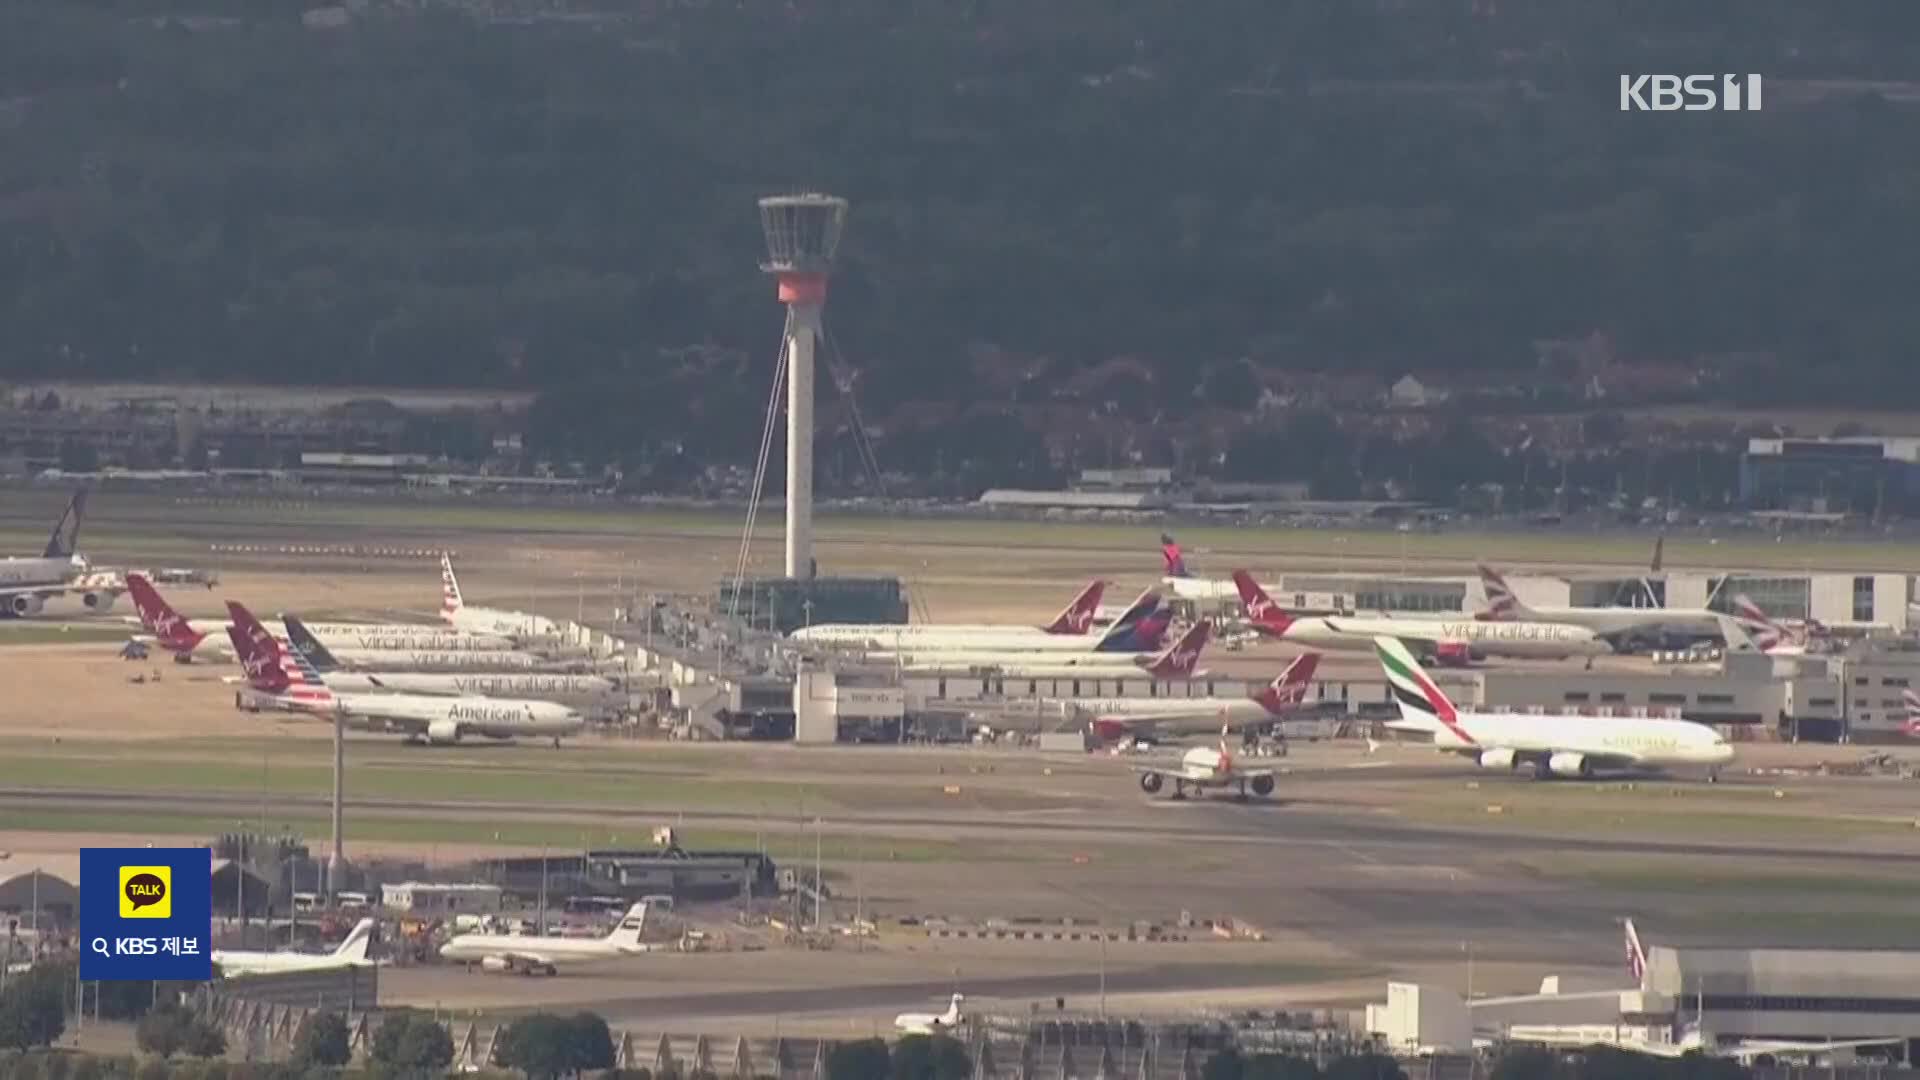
227, 601, 586, 746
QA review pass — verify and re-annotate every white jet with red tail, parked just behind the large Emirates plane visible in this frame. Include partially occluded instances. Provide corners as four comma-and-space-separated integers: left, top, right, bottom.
1233, 571, 1613, 667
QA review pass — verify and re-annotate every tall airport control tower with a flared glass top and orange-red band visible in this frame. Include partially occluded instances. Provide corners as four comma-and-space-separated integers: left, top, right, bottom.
760, 194, 847, 578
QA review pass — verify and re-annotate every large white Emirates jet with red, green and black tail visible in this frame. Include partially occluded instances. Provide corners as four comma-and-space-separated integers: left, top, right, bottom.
1373, 638, 1734, 780
